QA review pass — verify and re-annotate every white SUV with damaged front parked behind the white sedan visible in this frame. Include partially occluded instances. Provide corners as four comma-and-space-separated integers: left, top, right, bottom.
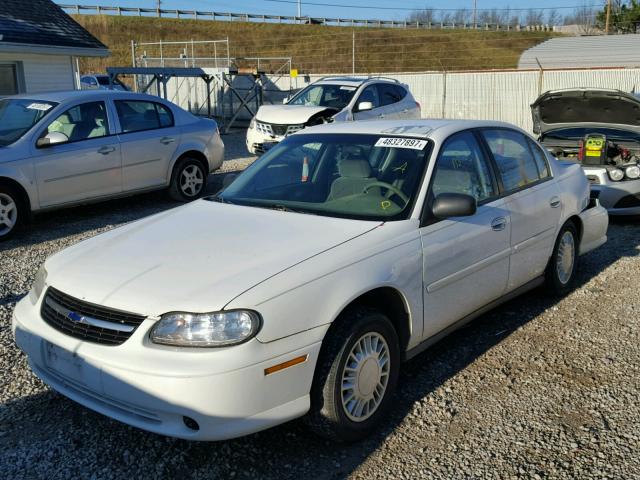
246, 77, 420, 154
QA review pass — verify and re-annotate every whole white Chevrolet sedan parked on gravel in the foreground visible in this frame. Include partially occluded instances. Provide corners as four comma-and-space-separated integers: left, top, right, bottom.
13, 120, 608, 440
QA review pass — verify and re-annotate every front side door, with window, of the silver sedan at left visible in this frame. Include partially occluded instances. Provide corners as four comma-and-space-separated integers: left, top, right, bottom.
33, 101, 122, 207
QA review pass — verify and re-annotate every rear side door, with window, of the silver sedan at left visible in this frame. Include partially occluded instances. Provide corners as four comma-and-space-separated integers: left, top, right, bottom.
114, 100, 181, 191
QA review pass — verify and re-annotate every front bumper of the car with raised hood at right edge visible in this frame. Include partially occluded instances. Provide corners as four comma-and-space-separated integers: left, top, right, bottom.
583, 167, 640, 215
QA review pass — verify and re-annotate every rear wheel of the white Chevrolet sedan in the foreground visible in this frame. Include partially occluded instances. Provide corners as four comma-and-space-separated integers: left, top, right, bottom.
545, 222, 579, 296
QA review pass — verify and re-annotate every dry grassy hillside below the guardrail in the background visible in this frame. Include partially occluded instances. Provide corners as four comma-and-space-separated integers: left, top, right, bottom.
74, 15, 554, 73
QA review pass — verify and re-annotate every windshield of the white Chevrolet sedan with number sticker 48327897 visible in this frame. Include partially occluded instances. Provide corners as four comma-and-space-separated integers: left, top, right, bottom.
211, 134, 430, 221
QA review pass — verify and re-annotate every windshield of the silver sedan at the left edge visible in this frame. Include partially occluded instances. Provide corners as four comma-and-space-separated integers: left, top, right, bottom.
0, 98, 57, 147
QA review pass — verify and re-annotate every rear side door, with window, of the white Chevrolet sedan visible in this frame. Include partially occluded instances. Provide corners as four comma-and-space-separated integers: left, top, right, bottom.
482, 128, 562, 290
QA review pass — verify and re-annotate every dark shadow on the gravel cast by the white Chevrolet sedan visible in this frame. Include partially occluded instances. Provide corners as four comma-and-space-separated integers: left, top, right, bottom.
0, 223, 640, 479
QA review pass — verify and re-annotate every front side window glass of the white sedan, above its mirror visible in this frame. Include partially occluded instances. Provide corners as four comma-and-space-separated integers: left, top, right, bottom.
431, 132, 497, 203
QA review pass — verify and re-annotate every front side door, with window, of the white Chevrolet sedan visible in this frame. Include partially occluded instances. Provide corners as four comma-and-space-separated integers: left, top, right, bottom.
420, 131, 511, 339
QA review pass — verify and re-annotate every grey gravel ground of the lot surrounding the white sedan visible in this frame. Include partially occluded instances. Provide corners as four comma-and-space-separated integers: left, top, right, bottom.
0, 134, 640, 479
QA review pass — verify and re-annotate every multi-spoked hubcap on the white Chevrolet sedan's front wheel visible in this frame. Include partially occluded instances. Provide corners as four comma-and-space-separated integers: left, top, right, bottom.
342, 332, 391, 422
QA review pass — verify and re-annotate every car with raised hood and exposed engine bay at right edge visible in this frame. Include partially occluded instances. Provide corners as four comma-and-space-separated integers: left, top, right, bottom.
531, 88, 640, 215
